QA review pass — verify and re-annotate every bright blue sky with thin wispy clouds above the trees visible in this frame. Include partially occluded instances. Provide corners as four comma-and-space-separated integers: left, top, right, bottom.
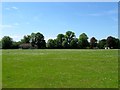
0, 2, 118, 41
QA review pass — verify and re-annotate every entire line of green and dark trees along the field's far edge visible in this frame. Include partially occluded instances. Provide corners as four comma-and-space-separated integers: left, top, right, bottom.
0, 31, 120, 49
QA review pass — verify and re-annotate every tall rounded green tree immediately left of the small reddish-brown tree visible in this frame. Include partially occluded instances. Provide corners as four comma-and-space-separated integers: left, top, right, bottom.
78, 33, 89, 49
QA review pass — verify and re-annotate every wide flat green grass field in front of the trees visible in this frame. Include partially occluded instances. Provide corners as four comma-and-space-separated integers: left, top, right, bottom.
2, 49, 118, 88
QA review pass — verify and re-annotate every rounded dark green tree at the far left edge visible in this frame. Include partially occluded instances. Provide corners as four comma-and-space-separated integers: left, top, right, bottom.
2, 36, 13, 49
